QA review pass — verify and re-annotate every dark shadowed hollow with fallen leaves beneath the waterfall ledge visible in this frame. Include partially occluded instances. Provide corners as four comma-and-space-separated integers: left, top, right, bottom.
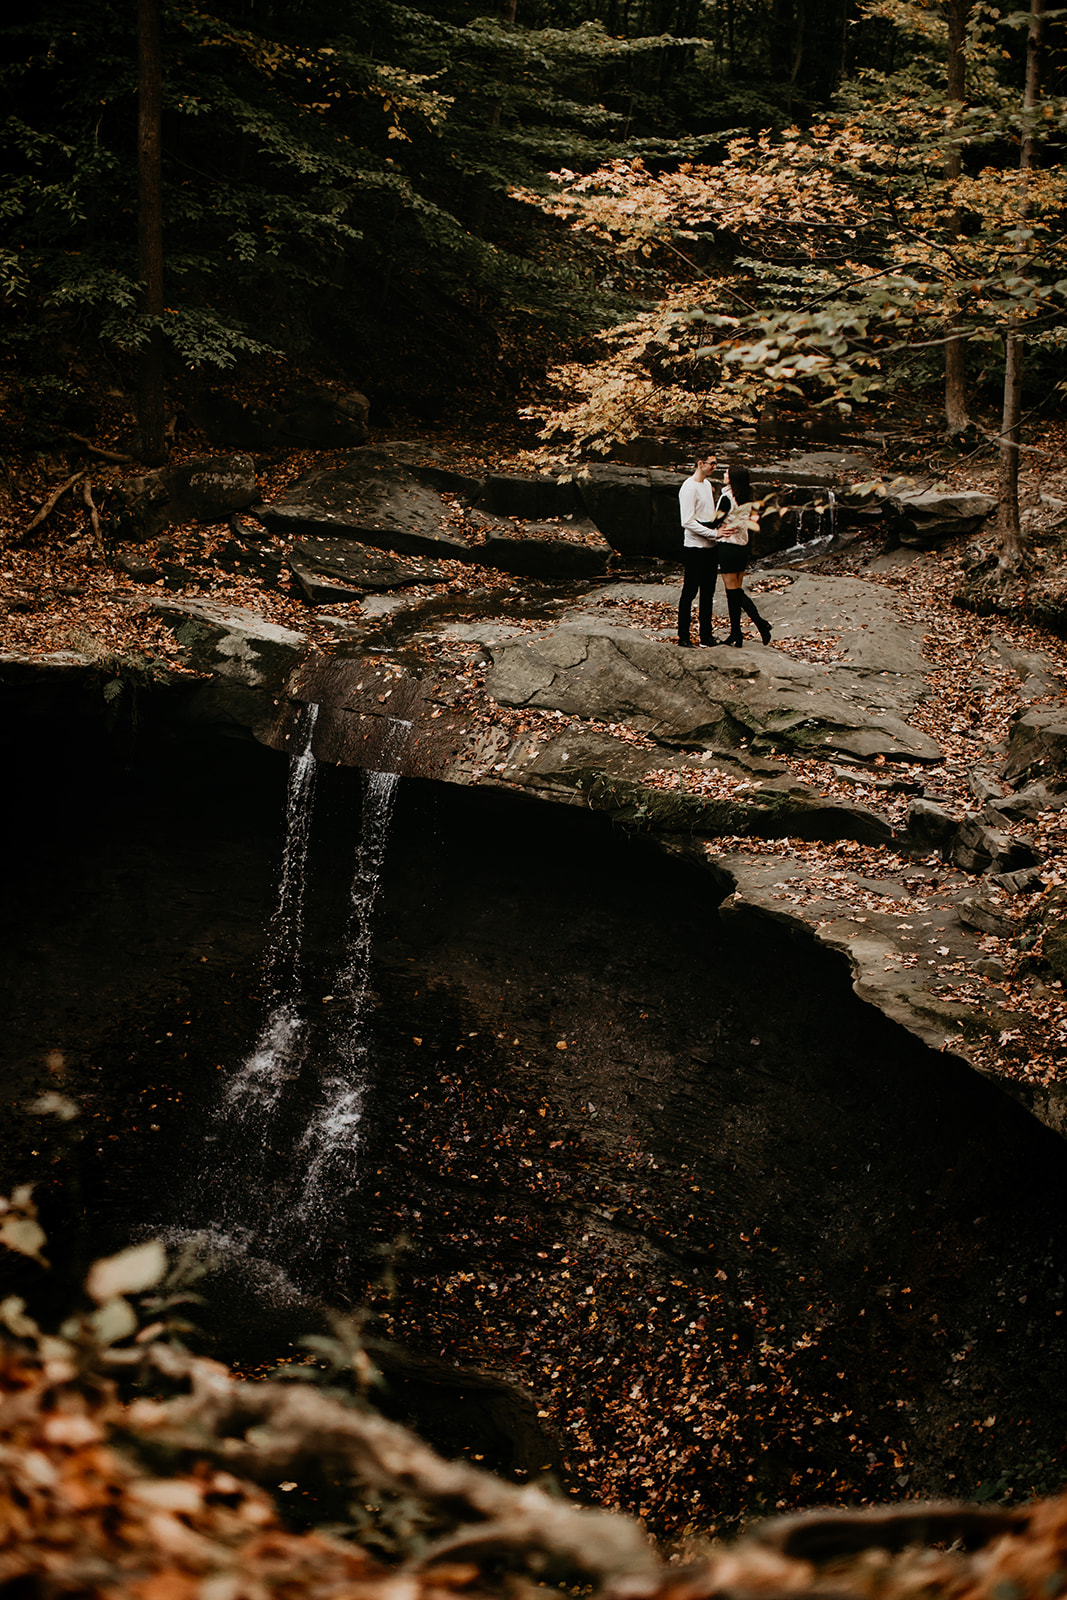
3, 704, 1067, 1534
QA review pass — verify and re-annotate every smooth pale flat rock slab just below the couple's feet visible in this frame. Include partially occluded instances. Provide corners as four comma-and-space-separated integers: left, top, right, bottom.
486, 624, 941, 762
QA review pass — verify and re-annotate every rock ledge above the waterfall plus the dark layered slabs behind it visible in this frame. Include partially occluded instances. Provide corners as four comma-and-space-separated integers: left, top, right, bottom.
5, 442, 1067, 1130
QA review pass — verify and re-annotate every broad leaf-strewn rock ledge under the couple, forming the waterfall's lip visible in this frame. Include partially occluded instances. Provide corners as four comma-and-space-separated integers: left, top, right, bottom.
58, 557, 1036, 1130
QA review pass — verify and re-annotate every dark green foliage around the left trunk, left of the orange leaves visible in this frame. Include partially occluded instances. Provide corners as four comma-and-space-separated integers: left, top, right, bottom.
0, 0, 735, 419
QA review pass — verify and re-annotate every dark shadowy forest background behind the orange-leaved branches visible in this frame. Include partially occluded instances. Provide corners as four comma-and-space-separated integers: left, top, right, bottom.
0, 0, 1064, 473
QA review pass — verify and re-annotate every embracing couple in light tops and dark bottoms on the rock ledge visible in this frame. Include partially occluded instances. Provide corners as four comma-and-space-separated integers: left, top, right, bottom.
678, 456, 771, 645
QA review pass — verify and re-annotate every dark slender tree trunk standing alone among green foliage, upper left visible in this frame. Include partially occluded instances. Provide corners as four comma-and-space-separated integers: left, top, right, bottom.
138, 0, 166, 466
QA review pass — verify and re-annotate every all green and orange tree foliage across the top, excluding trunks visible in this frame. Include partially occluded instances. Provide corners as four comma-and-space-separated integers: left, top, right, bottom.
0, 0, 1067, 438
